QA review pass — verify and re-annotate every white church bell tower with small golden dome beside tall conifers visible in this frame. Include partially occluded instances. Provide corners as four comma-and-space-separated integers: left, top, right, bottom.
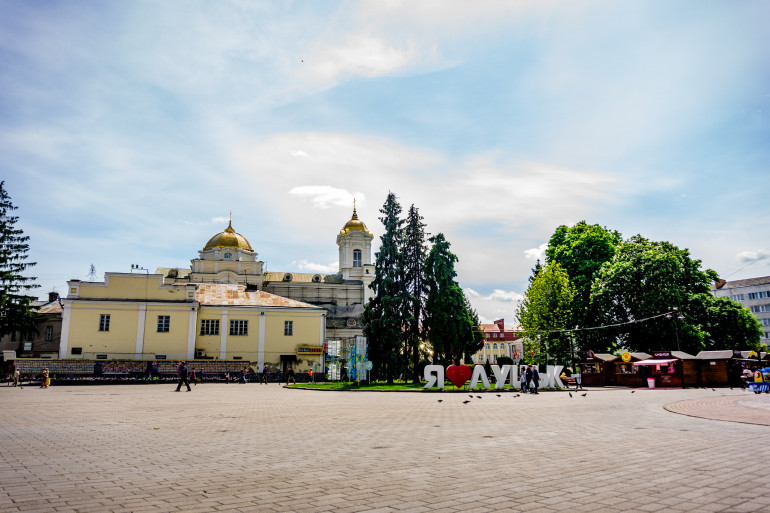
337, 202, 374, 304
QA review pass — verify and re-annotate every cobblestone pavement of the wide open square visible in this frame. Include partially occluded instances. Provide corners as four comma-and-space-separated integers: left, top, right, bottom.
0, 384, 770, 513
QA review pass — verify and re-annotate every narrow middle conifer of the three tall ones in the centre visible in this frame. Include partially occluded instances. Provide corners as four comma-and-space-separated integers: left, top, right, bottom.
401, 205, 428, 383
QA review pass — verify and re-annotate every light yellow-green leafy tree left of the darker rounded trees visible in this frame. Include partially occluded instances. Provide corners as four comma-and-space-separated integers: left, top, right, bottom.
516, 262, 575, 364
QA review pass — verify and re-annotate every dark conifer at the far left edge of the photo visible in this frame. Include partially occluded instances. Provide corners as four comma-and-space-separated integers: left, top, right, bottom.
0, 181, 39, 349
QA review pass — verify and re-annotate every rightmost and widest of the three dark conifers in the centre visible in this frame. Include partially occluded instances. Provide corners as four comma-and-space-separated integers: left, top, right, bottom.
425, 233, 476, 365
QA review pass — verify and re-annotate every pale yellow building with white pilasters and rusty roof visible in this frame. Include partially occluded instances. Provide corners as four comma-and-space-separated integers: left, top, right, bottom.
59, 273, 326, 370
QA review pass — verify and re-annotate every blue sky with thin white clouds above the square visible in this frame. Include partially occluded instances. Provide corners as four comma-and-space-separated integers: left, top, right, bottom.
0, 0, 770, 325
